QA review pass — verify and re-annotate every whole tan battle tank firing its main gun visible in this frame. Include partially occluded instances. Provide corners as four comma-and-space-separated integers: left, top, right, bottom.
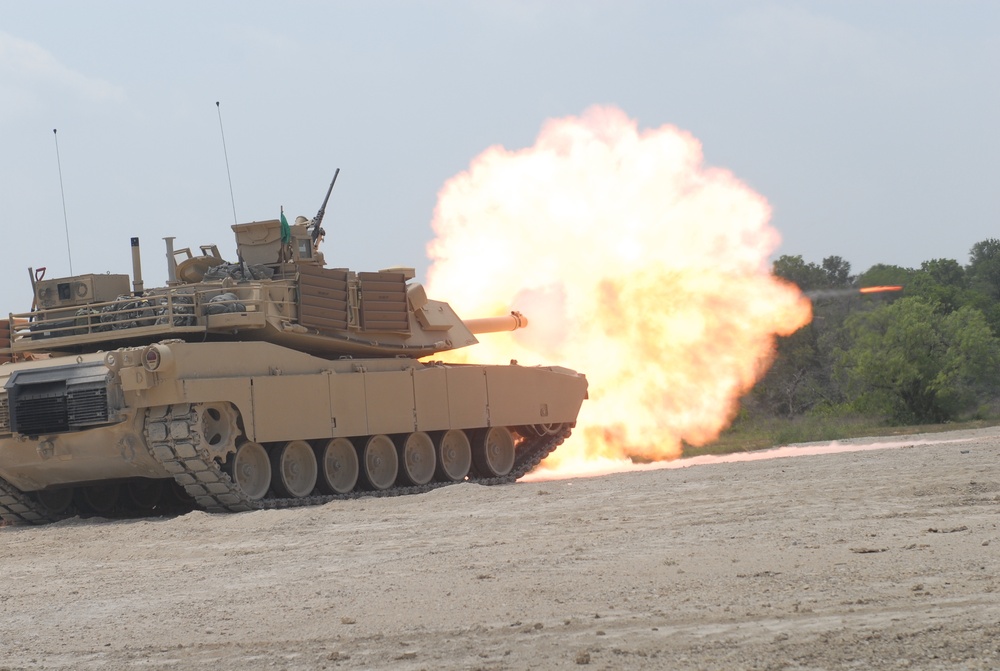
0, 178, 587, 523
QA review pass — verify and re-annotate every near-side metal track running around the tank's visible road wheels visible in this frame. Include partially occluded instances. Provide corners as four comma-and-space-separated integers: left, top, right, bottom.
145, 404, 572, 512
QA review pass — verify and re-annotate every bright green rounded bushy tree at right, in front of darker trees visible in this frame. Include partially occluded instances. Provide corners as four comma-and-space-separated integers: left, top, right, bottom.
837, 297, 1000, 424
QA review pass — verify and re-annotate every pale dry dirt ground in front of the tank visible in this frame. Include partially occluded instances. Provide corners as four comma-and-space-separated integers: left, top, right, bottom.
0, 429, 1000, 671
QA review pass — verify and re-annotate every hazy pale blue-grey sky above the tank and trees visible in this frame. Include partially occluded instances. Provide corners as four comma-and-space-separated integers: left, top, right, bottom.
0, 0, 1000, 312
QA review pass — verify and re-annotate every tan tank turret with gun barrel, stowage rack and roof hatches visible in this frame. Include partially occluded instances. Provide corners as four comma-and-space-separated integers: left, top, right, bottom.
3, 217, 527, 358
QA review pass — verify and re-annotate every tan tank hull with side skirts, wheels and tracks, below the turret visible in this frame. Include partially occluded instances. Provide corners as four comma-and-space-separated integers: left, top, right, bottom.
0, 341, 587, 522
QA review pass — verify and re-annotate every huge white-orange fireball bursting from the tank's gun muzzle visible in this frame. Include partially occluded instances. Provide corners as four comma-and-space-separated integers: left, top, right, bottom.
428, 107, 811, 473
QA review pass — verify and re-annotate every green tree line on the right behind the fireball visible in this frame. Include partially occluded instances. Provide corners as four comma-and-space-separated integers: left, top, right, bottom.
741, 239, 1000, 425
